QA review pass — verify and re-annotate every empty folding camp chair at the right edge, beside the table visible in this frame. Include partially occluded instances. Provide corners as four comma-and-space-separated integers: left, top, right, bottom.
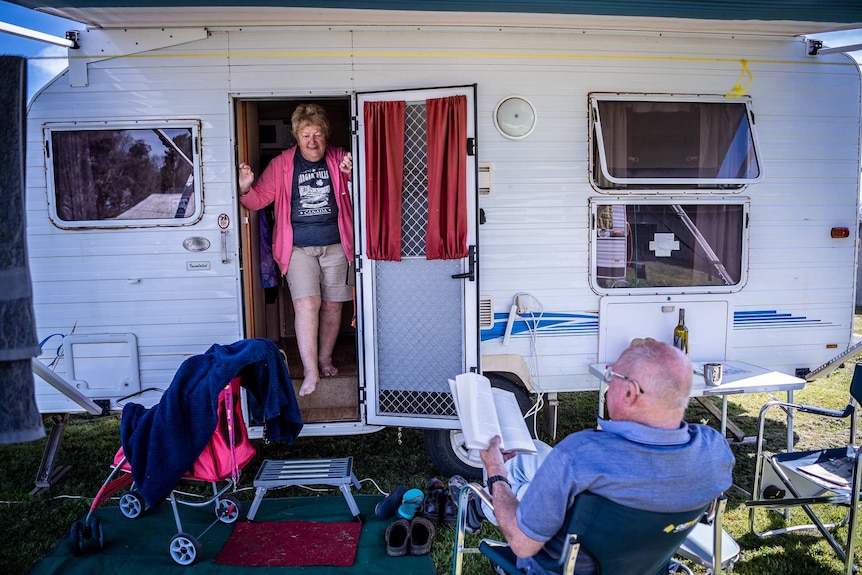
747, 363, 862, 575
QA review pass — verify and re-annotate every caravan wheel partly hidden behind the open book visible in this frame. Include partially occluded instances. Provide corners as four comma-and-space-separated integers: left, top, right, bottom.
425, 374, 535, 479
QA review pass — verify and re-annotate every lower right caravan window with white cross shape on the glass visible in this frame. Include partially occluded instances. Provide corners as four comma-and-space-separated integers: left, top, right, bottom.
591, 199, 748, 293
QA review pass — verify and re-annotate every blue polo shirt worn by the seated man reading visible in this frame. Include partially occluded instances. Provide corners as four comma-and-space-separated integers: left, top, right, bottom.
516, 419, 734, 574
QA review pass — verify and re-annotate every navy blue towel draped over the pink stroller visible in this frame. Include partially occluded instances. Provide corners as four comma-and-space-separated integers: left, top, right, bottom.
120, 339, 302, 507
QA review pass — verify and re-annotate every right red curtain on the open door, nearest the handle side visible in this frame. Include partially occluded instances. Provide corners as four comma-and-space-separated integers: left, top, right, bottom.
425, 96, 467, 260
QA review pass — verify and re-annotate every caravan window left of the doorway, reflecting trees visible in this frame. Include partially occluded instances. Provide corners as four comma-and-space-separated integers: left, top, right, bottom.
45, 122, 202, 227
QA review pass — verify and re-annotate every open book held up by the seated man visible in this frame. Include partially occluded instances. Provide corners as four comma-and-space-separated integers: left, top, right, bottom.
449, 373, 536, 453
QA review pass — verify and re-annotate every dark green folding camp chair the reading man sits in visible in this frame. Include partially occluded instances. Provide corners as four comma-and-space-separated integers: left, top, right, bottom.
452, 483, 723, 575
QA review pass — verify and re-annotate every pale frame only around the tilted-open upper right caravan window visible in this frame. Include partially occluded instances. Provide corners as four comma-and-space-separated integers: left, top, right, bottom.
588, 92, 763, 194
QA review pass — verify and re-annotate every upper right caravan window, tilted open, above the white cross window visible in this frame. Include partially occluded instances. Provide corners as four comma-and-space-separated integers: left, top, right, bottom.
590, 96, 761, 190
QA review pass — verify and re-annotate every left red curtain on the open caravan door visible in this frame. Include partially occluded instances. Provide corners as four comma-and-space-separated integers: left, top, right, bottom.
363, 101, 405, 261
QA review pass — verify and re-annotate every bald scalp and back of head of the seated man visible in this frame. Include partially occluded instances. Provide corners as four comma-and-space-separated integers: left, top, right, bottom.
614, 339, 692, 421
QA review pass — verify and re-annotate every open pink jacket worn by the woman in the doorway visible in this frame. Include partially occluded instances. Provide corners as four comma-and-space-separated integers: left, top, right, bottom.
239, 146, 353, 274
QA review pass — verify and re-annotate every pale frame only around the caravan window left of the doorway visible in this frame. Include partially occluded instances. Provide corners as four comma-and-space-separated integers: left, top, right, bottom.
42, 119, 204, 230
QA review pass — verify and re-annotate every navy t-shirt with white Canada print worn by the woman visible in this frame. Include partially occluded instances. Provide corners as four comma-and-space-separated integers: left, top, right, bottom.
290, 150, 341, 247
